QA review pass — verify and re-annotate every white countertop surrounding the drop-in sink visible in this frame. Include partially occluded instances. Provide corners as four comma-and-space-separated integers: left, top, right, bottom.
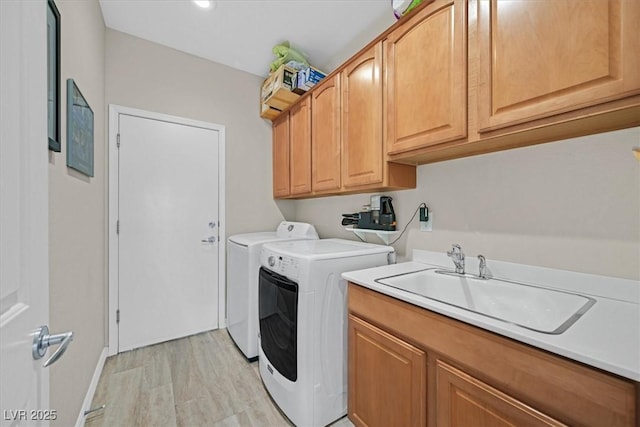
342, 251, 640, 381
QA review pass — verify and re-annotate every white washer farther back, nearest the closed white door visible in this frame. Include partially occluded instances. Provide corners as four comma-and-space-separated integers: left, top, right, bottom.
227, 221, 318, 361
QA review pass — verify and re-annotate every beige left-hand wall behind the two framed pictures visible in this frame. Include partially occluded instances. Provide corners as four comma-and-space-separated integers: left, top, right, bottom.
49, 0, 106, 426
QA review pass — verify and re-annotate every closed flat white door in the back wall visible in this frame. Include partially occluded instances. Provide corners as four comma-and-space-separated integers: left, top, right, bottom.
118, 114, 220, 351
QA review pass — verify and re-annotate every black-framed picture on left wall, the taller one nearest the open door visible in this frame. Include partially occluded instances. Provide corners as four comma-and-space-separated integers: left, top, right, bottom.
47, 0, 62, 153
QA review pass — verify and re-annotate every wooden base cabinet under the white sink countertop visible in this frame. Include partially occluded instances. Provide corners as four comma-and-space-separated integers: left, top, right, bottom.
347, 283, 640, 427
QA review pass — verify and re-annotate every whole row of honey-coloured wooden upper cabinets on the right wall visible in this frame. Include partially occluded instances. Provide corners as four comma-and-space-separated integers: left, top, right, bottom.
274, 0, 640, 171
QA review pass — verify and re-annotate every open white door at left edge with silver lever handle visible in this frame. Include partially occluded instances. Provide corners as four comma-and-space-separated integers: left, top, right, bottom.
0, 1, 50, 425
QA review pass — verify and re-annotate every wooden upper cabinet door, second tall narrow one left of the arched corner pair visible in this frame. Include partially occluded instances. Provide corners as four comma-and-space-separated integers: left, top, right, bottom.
342, 43, 384, 187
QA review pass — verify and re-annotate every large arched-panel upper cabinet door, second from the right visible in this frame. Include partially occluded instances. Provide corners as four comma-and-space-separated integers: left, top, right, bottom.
384, 0, 467, 154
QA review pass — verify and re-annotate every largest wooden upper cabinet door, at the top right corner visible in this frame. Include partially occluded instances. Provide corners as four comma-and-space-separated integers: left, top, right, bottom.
478, 0, 640, 132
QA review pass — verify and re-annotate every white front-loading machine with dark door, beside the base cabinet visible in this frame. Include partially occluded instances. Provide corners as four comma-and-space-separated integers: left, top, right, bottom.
259, 239, 395, 426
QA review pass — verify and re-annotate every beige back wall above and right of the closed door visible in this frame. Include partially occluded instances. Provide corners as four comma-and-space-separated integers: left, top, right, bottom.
106, 29, 283, 236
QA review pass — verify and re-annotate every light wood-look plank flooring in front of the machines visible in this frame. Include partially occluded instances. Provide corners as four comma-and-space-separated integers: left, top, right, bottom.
85, 329, 353, 427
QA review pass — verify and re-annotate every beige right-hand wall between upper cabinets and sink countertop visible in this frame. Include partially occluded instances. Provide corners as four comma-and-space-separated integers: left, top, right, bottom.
295, 128, 640, 279
